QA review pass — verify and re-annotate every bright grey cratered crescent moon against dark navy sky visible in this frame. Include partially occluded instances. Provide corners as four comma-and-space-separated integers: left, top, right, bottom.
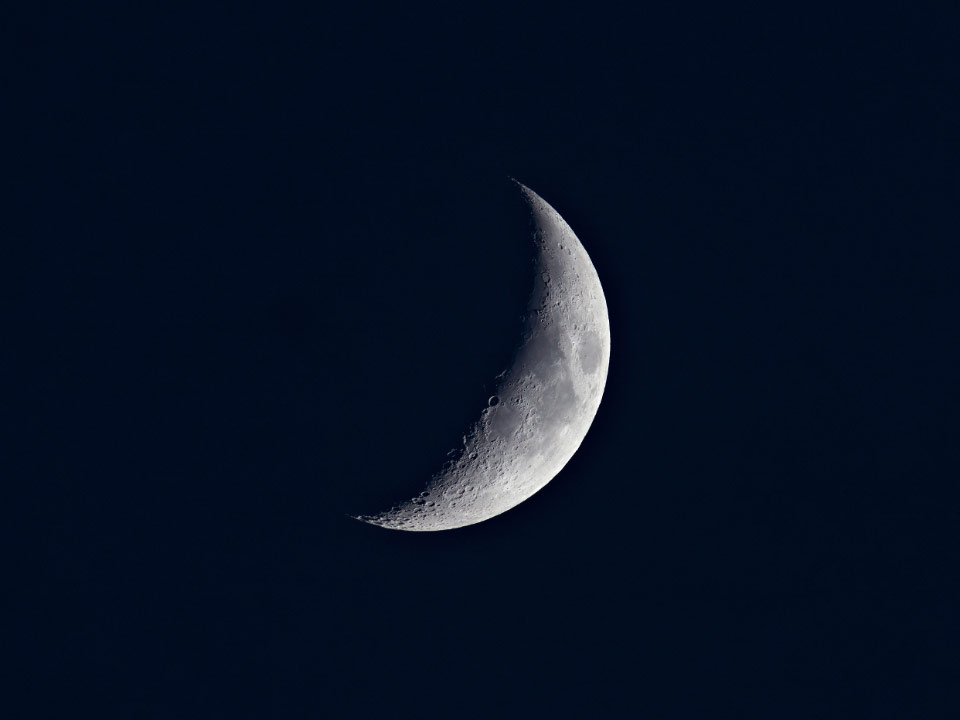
357, 183, 610, 532
